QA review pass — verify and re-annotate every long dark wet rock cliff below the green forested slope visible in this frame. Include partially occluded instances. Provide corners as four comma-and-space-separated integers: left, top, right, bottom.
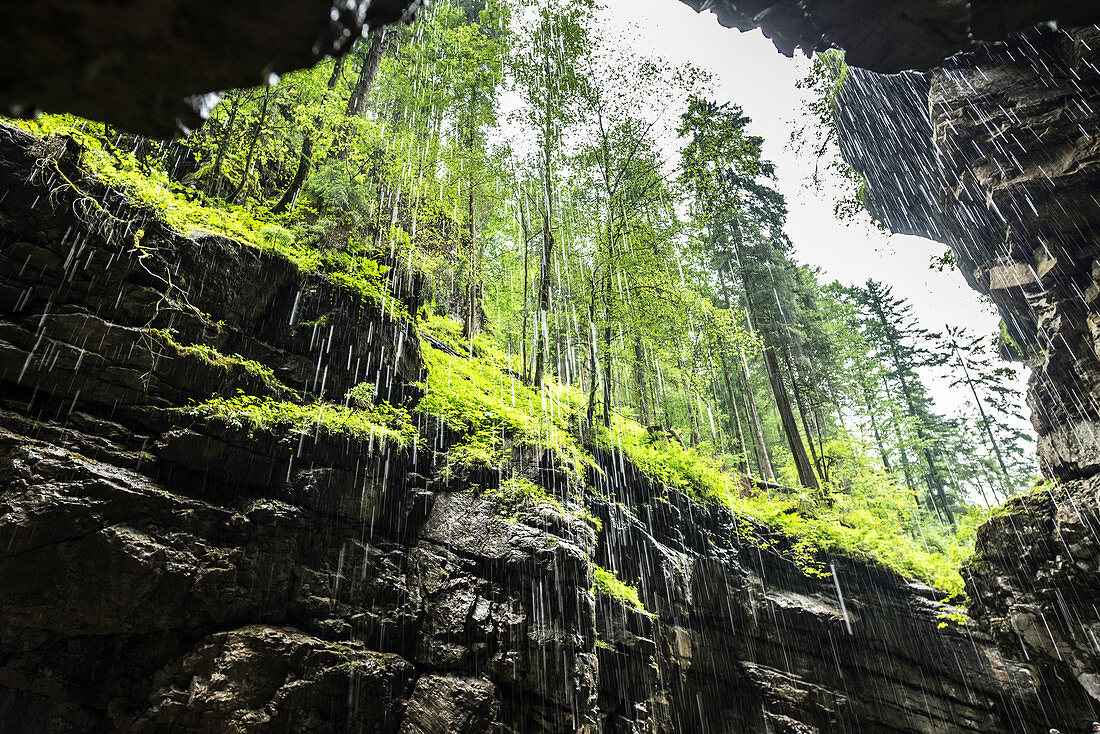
0, 120, 1064, 734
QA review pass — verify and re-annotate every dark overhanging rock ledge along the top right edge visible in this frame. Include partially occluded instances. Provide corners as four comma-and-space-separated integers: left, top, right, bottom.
683, 0, 1100, 74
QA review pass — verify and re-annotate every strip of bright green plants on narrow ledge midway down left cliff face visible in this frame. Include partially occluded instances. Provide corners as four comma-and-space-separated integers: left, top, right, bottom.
184, 394, 418, 447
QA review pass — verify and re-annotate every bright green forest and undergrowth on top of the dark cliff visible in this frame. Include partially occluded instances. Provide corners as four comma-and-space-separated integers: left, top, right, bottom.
6, 0, 1036, 593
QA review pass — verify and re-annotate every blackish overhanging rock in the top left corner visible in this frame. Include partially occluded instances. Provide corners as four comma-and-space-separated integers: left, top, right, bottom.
0, 0, 413, 138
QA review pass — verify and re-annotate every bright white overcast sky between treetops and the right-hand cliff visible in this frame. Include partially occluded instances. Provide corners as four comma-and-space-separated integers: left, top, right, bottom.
604, 0, 1023, 422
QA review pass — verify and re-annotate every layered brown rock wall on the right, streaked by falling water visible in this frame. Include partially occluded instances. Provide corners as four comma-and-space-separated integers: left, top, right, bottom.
838, 26, 1100, 725
